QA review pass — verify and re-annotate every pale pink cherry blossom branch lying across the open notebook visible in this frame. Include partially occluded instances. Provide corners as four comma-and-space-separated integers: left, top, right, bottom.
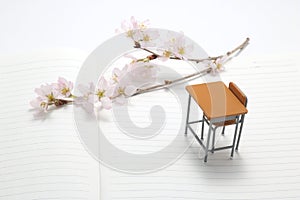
30, 17, 249, 113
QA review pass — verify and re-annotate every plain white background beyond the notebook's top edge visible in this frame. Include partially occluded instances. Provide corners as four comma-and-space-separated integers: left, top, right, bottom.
0, 0, 300, 56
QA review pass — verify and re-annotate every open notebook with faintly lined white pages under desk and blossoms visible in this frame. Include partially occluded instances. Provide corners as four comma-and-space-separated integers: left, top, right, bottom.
0, 50, 300, 200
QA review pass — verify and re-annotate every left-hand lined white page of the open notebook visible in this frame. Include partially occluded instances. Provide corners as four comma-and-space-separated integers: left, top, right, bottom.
0, 49, 99, 200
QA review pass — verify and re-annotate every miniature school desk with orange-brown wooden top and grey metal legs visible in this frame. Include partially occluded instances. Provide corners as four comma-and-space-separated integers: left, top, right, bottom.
185, 81, 248, 162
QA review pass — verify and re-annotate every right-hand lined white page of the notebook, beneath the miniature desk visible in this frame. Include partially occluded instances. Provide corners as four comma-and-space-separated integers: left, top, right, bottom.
101, 54, 300, 200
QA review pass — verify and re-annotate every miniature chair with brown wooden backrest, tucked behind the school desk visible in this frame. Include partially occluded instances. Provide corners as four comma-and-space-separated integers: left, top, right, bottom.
201, 82, 248, 152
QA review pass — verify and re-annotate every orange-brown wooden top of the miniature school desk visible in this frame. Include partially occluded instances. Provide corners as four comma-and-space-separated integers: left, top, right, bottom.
186, 81, 248, 119
